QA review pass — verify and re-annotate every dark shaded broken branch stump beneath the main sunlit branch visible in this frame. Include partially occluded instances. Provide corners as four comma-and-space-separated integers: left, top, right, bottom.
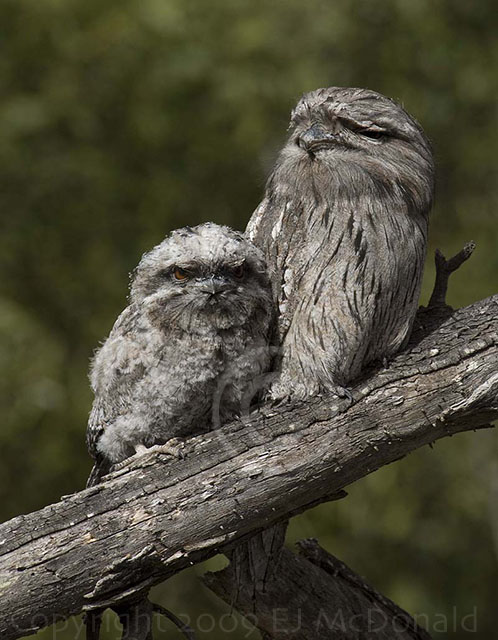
203, 540, 430, 640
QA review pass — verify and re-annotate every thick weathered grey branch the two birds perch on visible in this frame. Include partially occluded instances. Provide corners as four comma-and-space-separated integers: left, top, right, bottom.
0, 296, 498, 640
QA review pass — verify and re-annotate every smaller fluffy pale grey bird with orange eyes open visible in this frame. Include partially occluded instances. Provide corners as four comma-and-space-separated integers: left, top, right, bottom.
87, 223, 274, 485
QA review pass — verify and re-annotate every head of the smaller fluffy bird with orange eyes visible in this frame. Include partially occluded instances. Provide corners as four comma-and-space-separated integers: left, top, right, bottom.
130, 223, 272, 331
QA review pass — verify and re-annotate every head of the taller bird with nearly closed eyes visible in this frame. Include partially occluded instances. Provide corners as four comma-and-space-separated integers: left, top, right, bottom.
277, 87, 434, 210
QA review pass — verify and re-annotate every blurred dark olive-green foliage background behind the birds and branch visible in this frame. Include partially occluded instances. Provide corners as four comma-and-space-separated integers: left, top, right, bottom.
0, 0, 498, 640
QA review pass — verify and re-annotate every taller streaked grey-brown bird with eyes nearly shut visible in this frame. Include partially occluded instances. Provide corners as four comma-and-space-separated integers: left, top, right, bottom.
247, 87, 434, 398
